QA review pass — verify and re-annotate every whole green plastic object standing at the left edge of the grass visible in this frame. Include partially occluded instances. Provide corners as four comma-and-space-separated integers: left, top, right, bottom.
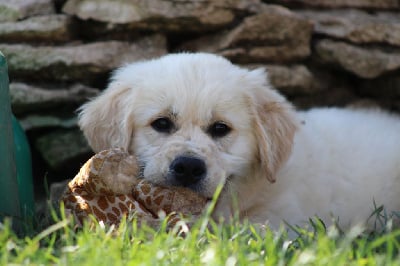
0, 52, 34, 225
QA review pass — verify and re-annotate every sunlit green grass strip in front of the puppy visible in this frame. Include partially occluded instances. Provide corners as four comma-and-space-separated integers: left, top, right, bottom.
0, 203, 400, 266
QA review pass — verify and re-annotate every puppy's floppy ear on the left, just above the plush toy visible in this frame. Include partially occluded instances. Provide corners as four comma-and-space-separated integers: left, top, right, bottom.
78, 81, 133, 152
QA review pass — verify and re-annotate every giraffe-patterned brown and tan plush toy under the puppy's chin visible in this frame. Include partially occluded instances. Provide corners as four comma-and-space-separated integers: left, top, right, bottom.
61, 149, 207, 227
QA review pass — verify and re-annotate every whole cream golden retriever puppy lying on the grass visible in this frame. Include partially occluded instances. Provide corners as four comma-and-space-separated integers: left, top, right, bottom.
79, 53, 400, 228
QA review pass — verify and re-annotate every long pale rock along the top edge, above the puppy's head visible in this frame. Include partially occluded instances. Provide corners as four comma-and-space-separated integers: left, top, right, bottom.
63, 0, 247, 31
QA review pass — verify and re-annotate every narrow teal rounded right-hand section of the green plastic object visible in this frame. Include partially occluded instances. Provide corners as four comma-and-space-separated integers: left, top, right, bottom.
12, 115, 35, 217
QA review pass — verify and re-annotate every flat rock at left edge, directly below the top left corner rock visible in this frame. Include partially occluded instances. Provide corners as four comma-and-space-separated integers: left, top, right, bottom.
0, 15, 71, 42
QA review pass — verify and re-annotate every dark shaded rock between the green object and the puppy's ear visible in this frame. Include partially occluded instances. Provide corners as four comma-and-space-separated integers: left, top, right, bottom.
34, 129, 91, 169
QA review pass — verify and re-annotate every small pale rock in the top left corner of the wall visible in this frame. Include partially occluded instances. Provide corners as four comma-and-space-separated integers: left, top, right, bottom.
0, 0, 55, 22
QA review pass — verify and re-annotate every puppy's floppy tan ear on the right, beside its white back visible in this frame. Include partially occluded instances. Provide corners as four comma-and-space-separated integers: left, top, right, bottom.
250, 69, 298, 182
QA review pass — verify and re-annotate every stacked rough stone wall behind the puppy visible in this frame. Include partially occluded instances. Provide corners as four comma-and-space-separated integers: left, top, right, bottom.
0, 0, 400, 195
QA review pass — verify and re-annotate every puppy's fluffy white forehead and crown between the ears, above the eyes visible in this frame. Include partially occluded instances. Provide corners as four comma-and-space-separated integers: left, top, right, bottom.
121, 54, 260, 123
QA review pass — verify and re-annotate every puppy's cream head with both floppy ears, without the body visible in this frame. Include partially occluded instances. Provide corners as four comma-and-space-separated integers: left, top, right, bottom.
79, 54, 295, 197
